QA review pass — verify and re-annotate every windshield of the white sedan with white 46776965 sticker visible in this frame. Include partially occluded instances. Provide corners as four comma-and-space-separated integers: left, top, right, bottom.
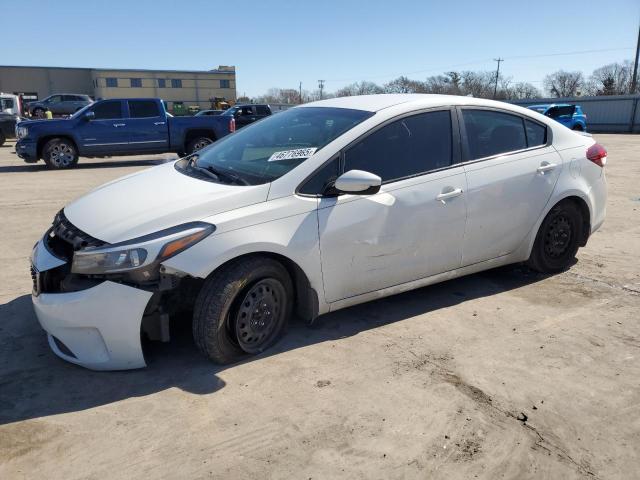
176, 107, 373, 185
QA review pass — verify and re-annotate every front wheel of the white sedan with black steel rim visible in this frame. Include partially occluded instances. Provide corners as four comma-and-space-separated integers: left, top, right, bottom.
193, 257, 293, 364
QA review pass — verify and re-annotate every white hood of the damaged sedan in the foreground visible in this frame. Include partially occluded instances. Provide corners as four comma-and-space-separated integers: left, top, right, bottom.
64, 162, 269, 243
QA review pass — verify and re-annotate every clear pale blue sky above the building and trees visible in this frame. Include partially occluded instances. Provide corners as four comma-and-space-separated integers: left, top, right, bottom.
6, 0, 640, 96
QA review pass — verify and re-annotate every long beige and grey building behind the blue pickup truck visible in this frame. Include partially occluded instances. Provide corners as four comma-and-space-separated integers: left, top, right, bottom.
0, 65, 236, 111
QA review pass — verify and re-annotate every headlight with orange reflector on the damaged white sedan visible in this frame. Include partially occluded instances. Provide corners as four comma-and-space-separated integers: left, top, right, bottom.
71, 222, 215, 275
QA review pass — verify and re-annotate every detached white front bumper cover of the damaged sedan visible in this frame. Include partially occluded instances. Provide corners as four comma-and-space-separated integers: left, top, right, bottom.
31, 239, 153, 370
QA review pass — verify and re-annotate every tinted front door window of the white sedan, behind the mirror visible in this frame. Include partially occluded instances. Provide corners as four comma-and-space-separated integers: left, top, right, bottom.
344, 110, 453, 183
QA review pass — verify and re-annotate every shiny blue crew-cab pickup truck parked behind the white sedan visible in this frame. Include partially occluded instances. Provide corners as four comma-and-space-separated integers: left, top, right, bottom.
16, 98, 235, 169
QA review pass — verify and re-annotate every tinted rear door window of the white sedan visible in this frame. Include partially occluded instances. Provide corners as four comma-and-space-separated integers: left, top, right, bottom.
462, 109, 527, 160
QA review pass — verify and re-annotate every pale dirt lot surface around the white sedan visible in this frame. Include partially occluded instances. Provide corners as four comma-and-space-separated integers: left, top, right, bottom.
0, 135, 640, 480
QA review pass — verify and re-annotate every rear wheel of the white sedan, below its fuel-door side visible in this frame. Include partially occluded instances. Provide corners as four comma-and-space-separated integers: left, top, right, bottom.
527, 200, 584, 273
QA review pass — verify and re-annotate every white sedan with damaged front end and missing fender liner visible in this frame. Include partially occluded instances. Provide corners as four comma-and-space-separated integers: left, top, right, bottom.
32, 95, 607, 370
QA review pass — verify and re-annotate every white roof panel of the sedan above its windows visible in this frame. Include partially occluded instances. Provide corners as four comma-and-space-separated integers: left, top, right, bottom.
299, 93, 536, 112
